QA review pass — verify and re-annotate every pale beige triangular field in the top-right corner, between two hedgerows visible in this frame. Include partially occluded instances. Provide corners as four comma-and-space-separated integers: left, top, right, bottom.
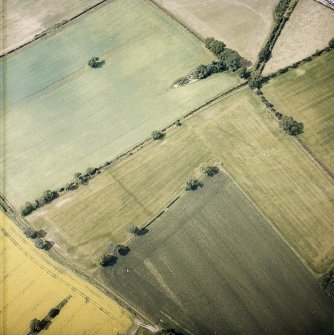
263, 0, 334, 75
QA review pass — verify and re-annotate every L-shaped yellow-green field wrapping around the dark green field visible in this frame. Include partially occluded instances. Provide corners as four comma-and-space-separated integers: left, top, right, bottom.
27, 89, 334, 272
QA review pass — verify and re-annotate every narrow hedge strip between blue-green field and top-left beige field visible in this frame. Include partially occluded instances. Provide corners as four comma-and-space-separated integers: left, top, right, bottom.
0, 0, 114, 59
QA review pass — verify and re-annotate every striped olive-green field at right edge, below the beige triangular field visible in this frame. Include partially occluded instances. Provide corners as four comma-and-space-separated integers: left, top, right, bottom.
262, 51, 334, 171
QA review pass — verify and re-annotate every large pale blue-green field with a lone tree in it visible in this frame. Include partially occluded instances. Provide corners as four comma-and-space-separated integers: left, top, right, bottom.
0, 0, 240, 205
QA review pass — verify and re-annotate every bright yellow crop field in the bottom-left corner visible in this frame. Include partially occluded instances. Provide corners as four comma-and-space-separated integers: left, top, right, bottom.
0, 212, 133, 335
